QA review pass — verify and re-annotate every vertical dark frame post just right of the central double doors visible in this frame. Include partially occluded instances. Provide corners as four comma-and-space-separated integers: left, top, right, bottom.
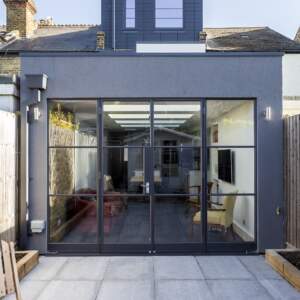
201, 99, 208, 251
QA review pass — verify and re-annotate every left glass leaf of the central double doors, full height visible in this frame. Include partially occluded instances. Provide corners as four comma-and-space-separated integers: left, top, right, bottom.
101, 100, 152, 247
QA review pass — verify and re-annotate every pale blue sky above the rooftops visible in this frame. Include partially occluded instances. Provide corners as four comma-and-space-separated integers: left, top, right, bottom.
0, 0, 300, 38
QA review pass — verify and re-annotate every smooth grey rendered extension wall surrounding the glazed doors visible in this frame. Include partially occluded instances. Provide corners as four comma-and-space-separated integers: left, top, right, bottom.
21, 54, 283, 252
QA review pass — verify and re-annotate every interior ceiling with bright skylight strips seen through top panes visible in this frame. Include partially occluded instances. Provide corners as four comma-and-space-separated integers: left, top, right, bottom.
53, 100, 245, 129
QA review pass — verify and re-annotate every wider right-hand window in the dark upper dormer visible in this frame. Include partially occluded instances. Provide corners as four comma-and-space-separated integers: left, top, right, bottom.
155, 0, 183, 28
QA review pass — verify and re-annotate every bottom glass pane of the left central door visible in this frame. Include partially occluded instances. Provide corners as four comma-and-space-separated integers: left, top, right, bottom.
104, 194, 150, 244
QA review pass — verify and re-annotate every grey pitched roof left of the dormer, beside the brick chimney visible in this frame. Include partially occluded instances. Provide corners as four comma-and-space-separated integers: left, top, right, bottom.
0, 25, 100, 52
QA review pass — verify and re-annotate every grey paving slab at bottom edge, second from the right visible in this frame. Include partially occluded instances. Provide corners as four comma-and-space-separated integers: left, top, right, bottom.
207, 280, 273, 300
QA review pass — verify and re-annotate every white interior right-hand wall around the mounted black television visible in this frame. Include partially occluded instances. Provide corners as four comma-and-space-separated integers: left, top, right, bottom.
209, 102, 255, 239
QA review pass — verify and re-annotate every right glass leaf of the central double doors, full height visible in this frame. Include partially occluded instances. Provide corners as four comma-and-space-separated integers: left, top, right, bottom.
151, 100, 203, 249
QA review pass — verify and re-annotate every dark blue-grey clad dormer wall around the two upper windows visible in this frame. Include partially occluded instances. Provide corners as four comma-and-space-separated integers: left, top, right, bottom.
101, 0, 203, 49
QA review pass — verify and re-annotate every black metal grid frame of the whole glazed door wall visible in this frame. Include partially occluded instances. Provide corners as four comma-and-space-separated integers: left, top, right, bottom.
47, 98, 258, 255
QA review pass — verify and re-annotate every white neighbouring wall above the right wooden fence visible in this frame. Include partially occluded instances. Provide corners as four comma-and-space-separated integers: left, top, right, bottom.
282, 54, 300, 115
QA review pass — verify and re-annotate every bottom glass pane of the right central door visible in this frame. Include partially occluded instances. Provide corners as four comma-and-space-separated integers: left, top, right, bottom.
154, 195, 202, 244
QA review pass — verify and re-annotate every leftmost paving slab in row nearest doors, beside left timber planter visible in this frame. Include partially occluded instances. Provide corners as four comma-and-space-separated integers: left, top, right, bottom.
24, 256, 68, 280
